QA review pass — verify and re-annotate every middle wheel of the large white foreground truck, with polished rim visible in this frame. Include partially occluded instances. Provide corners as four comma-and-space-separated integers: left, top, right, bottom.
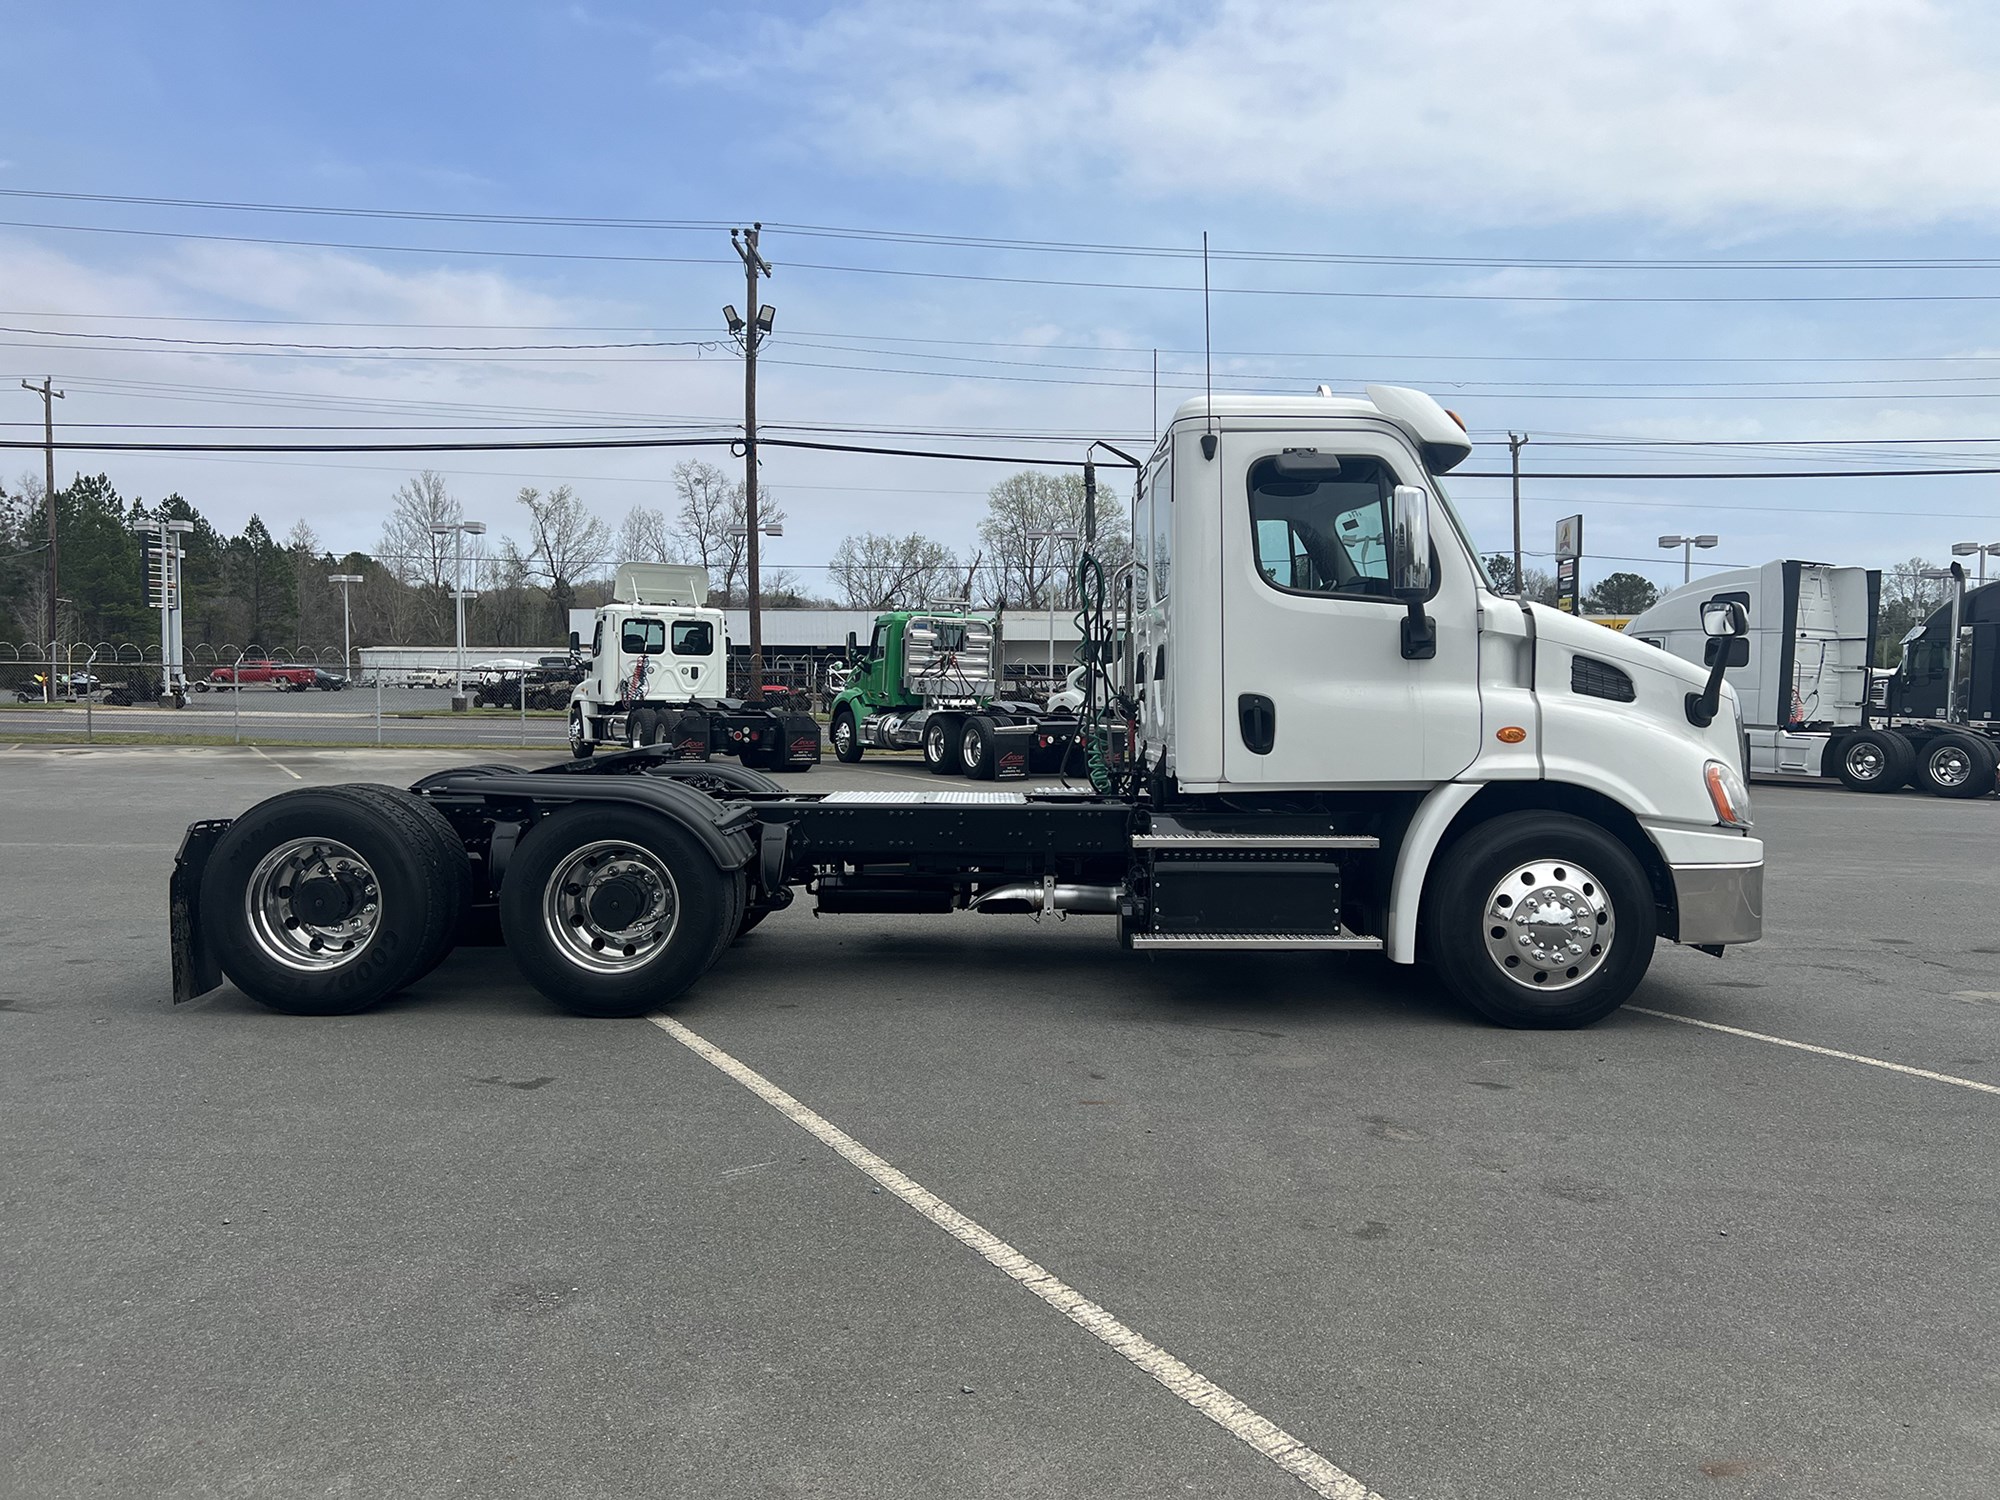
500, 804, 742, 1016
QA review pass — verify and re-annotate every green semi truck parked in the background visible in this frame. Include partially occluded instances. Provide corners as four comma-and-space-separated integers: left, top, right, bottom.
830, 608, 1082, 780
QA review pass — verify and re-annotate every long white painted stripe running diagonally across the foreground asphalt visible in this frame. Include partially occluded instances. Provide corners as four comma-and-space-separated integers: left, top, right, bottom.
648, 1016, 1382, 1500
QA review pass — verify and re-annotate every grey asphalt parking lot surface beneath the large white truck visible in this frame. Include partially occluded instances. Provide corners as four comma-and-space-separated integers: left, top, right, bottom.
0, 746, 2000, 1500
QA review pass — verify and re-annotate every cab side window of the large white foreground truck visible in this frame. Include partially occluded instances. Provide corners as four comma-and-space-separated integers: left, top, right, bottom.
1250, 454, 1396, 598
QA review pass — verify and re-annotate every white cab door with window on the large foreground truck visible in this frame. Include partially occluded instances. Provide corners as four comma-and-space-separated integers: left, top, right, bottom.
1216, 430, 1480, 788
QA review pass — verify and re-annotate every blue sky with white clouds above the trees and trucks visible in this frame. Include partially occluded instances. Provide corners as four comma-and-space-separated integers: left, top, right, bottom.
0, 0, 2000, 600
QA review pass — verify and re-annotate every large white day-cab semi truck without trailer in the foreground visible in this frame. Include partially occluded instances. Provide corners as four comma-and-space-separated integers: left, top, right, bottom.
172, 386, 1764, 1026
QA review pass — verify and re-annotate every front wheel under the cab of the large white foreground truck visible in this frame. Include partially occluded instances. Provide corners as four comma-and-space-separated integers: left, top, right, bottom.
1426, 812, 1658, 1030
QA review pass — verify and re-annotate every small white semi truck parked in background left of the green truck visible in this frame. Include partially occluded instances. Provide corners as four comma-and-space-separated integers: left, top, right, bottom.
568, 562, 822, 770
